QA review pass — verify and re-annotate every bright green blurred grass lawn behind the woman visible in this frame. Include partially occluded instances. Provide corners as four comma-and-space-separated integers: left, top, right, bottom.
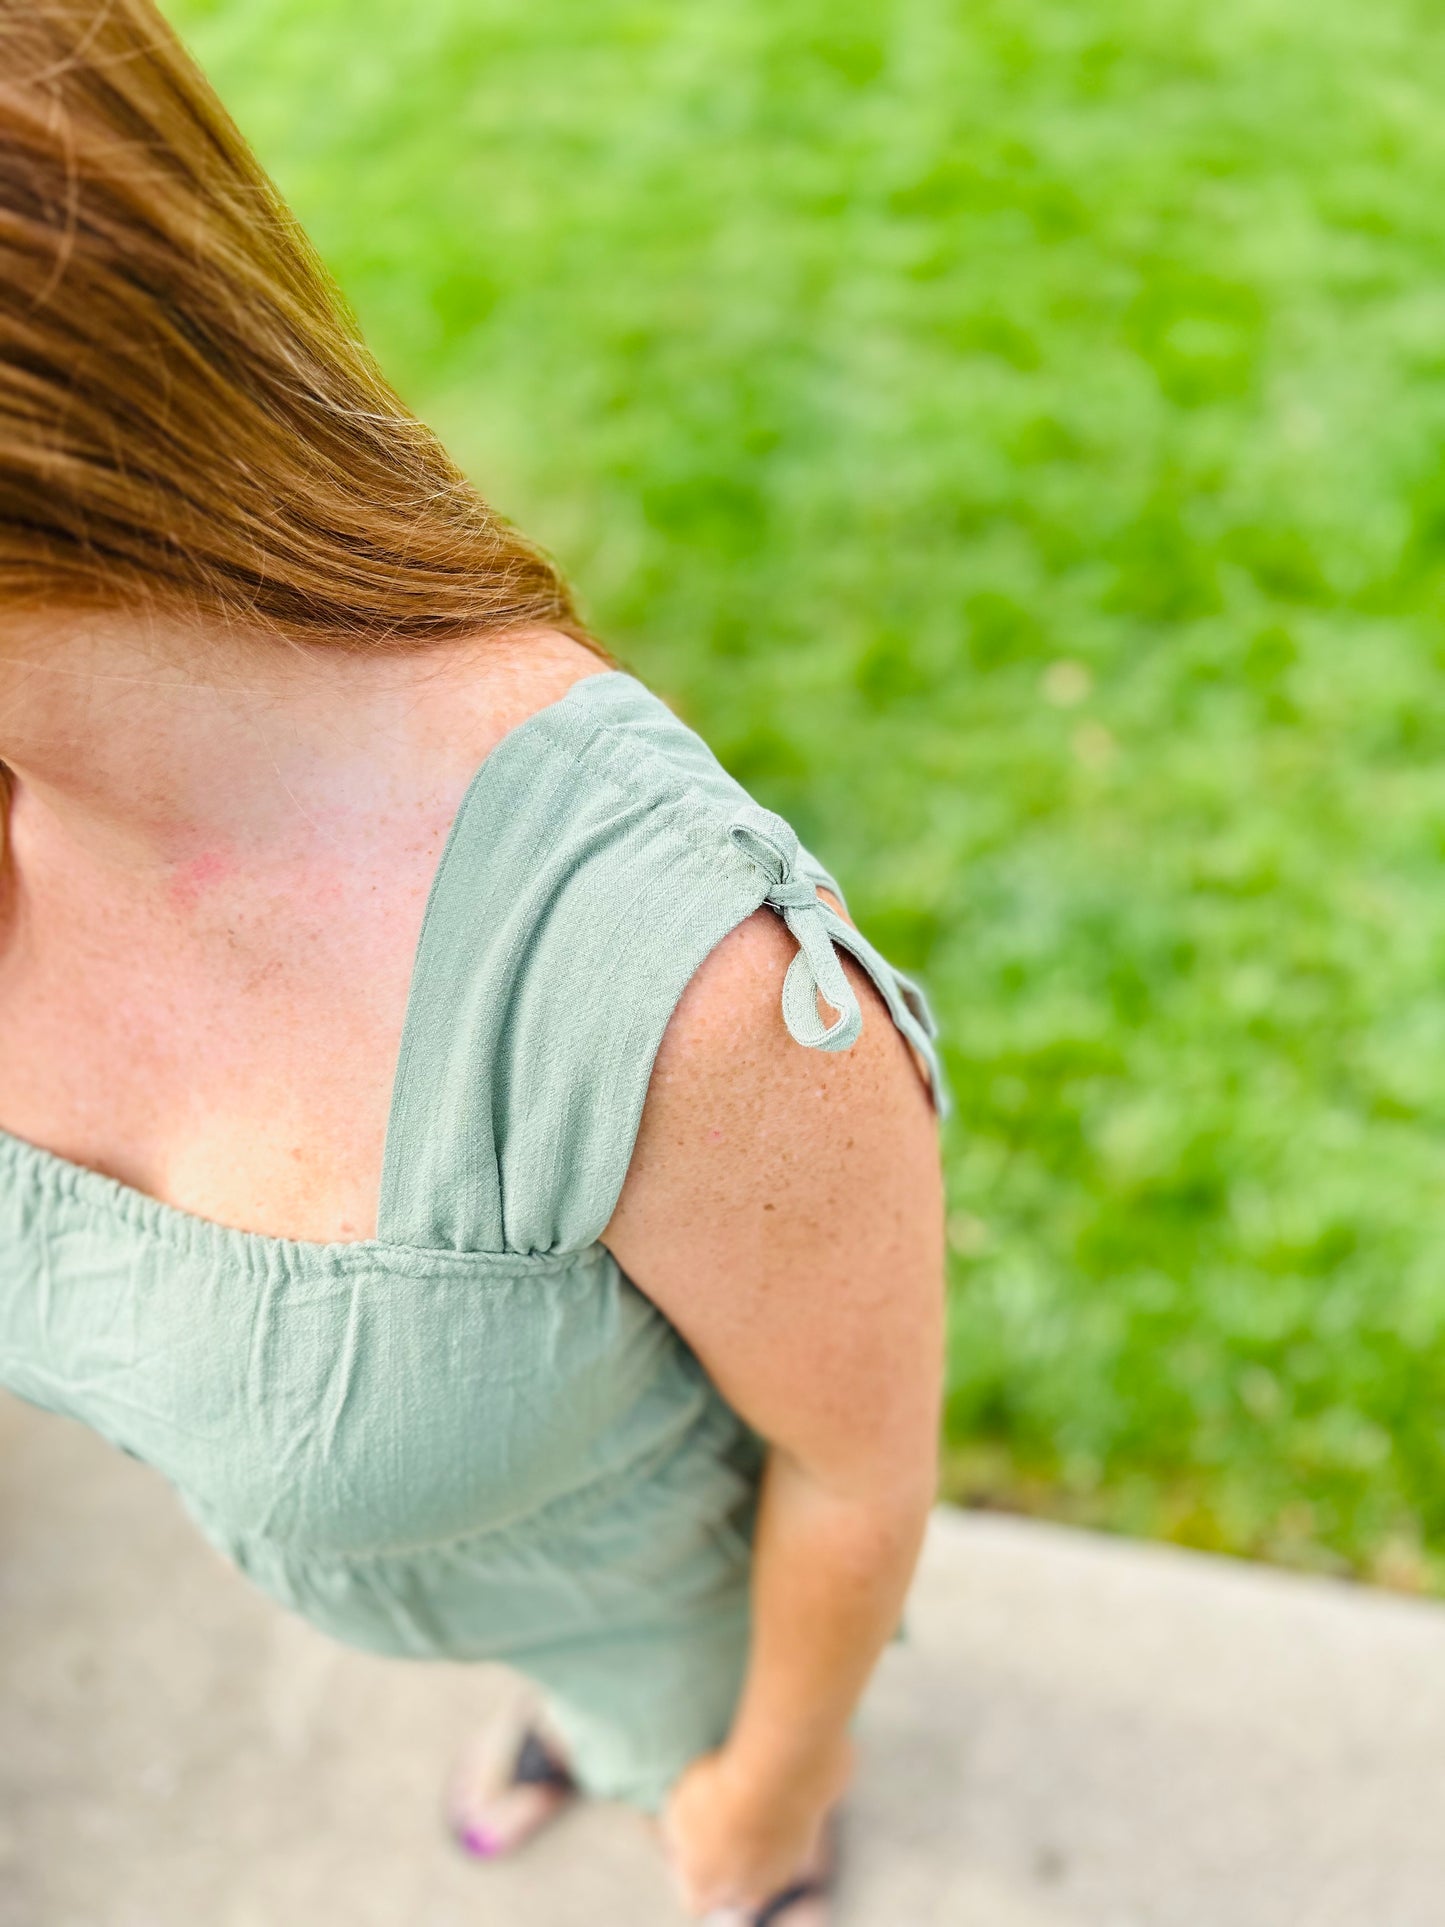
175, 0, 1445, 1586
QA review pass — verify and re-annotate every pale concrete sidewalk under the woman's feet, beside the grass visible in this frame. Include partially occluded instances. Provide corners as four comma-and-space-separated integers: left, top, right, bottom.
0, 1401, 1445, 1927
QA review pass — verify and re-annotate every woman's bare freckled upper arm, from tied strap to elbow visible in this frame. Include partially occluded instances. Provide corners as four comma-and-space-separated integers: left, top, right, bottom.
603, 910, 942, 1491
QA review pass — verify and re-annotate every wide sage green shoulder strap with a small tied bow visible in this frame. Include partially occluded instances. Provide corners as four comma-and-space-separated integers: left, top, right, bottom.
380, 673, 946, 1253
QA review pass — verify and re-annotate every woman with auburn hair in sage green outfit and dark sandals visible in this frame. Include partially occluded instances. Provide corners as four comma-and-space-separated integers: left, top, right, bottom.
0, 0, 942, 1927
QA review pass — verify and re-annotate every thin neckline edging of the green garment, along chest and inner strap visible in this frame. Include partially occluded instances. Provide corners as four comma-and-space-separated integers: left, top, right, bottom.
0, 669, 644, 1264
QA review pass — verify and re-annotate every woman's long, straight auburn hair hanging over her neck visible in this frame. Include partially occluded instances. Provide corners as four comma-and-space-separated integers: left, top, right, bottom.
0, 0, 595, 649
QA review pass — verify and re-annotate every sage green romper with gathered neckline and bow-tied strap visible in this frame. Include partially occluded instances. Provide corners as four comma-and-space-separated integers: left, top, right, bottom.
0, 671, 944, 1808
